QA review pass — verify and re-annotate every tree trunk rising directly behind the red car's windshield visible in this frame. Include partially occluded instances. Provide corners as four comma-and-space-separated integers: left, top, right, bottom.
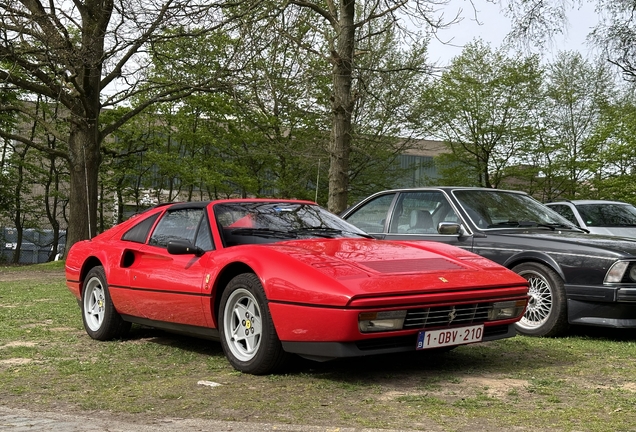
327, 0, 355, 213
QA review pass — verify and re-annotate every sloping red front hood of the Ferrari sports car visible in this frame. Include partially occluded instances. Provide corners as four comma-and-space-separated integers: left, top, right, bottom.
268, 239, 527, 304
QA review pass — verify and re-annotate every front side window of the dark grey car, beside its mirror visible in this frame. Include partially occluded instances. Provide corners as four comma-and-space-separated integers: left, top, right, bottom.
389, 191, 459, 234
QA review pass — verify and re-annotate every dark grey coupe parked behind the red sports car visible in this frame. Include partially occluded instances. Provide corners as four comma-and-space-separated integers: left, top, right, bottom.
341, 187, 636, 336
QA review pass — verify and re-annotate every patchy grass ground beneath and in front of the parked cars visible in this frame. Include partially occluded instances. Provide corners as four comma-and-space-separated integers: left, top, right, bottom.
0, 264, 636, 431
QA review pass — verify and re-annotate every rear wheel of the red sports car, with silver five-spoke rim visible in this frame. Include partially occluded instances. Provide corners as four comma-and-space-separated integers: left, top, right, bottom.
80, 266, 131, 341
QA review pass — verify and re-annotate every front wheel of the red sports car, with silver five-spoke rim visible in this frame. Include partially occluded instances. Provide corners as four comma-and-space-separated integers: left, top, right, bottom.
219, 273, 289, 375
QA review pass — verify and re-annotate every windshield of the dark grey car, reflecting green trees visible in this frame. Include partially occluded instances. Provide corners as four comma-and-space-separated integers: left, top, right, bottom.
453, 189, 575, 229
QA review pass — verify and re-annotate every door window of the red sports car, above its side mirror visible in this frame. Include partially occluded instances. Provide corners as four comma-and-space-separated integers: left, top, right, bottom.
148, 208, 204, 248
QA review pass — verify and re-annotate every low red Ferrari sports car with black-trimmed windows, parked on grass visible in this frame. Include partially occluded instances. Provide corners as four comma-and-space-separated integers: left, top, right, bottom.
66, 199, 528, 374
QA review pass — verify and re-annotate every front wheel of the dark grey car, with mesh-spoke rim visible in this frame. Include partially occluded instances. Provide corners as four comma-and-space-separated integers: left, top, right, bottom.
512, 262, 569, 336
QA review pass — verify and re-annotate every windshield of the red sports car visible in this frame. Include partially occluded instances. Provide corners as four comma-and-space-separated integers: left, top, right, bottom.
214, 202, 370, 247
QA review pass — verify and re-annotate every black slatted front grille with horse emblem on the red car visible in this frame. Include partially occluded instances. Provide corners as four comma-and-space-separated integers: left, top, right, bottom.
403, 303, 492, 330
